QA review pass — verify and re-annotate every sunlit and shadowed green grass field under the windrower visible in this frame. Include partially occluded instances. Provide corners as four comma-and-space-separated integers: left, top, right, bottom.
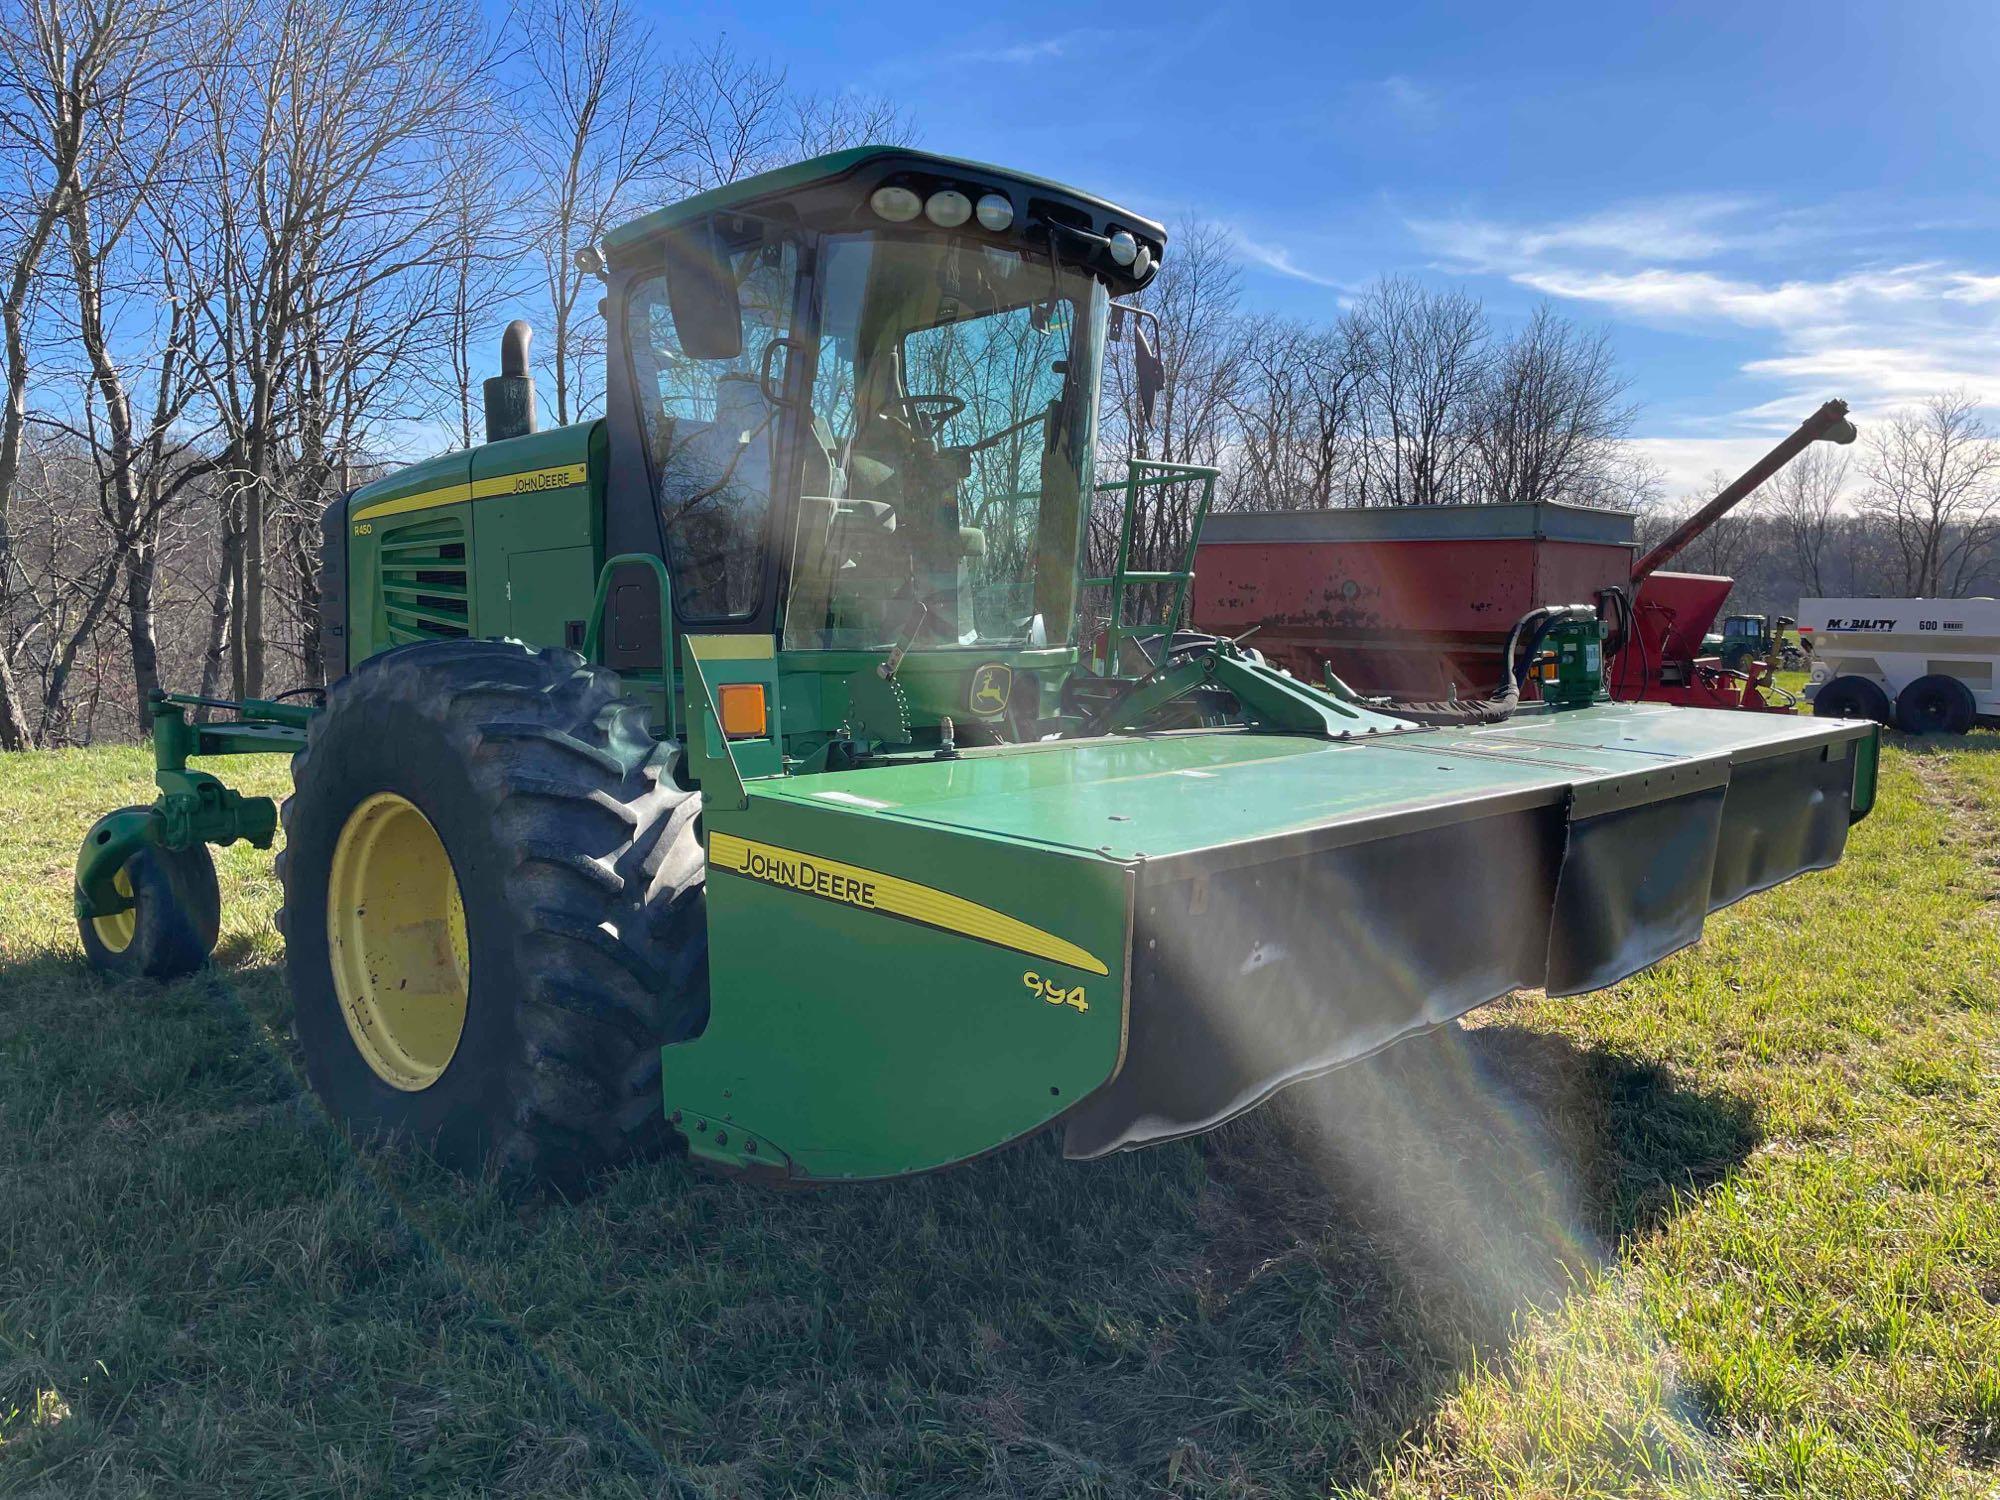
0, 734, 2000, 1500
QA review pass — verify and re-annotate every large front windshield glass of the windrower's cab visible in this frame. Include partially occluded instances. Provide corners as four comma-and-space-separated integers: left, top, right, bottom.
784, 234, 1106, 650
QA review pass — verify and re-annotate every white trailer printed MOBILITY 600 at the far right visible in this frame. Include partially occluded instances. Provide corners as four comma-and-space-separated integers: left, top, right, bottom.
1798, 598, 2000, 734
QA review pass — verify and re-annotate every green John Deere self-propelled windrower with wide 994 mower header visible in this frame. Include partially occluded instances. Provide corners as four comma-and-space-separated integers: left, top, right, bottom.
78, 148, 1876, 1180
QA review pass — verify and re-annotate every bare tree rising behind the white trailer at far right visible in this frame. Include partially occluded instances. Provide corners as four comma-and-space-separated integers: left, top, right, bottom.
1862, 390, 2000, 596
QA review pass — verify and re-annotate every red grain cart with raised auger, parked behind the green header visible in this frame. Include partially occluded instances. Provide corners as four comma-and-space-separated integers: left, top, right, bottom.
1194, 402, 1854, 712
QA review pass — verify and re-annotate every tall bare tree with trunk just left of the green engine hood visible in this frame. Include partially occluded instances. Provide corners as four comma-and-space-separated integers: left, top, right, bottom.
184, 0, 488, 696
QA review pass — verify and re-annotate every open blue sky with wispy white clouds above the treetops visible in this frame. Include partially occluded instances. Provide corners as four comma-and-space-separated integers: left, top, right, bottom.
656, 0, 2000, 492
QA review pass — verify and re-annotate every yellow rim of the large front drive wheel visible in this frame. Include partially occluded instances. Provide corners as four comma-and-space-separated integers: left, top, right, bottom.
326, 792, 472, 1092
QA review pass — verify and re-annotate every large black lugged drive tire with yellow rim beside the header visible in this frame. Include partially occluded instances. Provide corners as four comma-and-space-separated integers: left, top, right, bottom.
280, 640, 708, 1188
